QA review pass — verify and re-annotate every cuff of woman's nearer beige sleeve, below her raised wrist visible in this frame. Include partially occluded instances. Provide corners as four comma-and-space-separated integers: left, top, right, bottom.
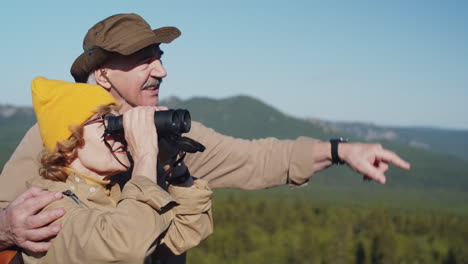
119, 176, 177, 211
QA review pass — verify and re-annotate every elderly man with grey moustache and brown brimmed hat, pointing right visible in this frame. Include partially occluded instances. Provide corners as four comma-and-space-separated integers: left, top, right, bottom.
0, 14, 410, 258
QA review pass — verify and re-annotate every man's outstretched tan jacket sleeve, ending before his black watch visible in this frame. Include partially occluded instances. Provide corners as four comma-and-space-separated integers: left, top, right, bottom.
185, 122, 316, 189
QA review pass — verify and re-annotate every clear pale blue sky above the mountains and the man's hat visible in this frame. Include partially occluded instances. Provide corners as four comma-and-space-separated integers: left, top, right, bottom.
0, 0, 468, 129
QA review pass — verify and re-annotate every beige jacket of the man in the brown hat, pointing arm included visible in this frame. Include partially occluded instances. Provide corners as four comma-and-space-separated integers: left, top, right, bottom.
0, 122, 315, 208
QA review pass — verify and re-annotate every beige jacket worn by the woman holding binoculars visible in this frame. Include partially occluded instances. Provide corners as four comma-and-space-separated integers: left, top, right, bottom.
23, 174, 213, 264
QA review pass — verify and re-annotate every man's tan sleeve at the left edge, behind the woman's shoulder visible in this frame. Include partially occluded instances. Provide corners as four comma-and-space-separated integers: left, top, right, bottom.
0, 124, 43, 208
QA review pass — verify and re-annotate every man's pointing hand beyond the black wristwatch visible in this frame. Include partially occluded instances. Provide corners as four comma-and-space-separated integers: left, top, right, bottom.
338, 143, 411, 184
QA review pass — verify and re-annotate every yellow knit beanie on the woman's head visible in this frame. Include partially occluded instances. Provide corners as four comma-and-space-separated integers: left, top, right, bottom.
31, 77, 117, 151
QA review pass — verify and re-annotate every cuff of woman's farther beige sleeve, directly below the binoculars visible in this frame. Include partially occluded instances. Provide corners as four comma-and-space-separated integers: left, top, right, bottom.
168, 179, 213, 215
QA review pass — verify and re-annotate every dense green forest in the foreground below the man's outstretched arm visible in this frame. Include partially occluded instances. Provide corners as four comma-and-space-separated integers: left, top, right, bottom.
187, 194, 468, 264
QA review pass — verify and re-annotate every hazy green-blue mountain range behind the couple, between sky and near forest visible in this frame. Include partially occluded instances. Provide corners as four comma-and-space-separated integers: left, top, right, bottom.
0, 96, 468, 210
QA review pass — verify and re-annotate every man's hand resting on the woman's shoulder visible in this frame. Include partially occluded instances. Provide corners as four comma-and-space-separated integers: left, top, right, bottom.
0, 187, 65, 253
